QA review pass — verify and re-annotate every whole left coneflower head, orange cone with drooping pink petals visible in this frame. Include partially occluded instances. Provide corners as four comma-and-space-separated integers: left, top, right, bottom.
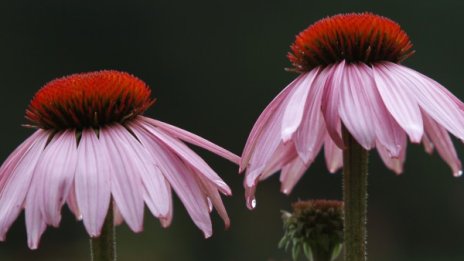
0, 71, 240, 249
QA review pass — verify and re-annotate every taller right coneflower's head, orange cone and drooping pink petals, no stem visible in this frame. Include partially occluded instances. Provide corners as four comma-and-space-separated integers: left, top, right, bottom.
240, 13, 464, 208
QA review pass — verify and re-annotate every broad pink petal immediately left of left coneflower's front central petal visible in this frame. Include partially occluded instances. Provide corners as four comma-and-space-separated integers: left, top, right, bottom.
34, 130, 77, 227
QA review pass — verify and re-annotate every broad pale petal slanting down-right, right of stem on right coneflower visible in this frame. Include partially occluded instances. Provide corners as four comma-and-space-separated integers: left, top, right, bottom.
372, 63, 424, 143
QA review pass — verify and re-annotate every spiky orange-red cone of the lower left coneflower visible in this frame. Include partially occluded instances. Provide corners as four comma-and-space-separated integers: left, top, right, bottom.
26, 70, 153, 130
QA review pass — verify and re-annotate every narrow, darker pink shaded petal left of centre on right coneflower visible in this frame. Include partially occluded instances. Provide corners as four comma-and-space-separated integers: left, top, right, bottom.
321, 61, 345, 148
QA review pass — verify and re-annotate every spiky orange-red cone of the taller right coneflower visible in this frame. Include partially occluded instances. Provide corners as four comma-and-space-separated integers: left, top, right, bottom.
288, 13, 414, 72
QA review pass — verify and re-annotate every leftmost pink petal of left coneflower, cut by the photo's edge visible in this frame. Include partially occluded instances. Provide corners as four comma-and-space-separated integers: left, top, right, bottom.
0, 130, 50, 240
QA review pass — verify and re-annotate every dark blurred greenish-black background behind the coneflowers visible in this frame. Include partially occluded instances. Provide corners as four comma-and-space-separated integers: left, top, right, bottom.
0, 0, 464, 261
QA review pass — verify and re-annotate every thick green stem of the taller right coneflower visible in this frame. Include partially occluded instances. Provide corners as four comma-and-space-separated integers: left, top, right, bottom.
342, 128, 368, 261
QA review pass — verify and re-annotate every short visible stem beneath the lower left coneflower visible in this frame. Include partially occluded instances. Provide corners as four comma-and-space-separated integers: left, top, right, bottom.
90, 204, 116, 261
